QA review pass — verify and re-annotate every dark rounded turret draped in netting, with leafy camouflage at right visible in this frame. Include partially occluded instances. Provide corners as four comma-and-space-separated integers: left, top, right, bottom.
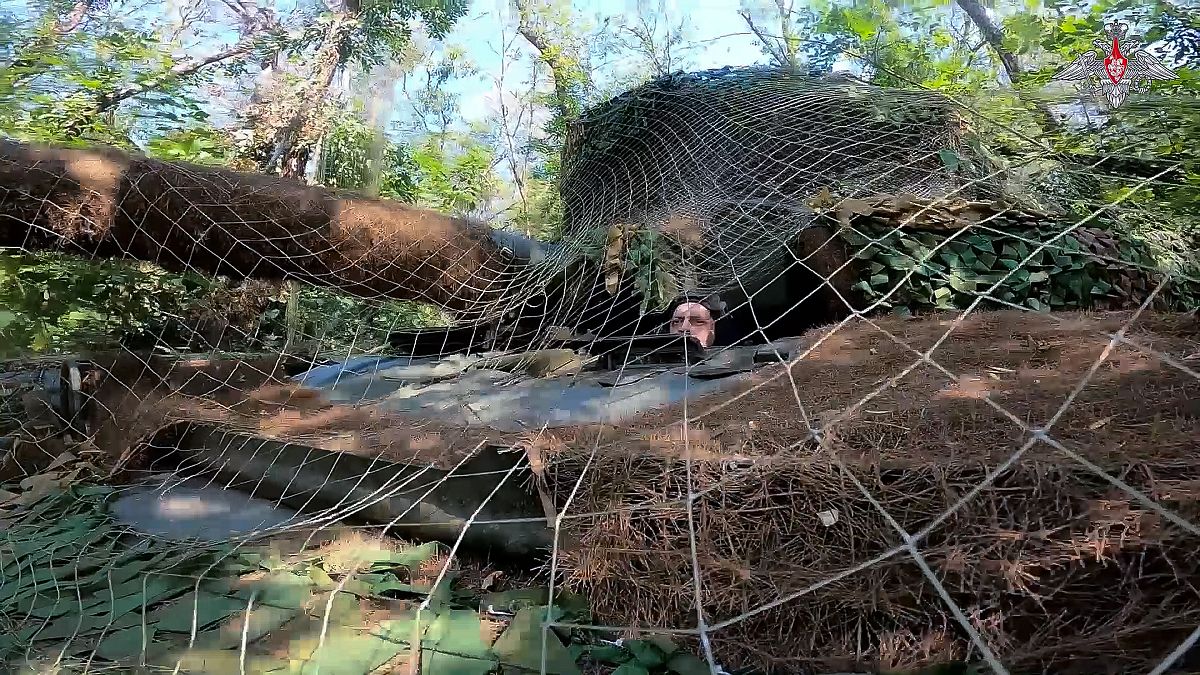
552, 68, 1198, 325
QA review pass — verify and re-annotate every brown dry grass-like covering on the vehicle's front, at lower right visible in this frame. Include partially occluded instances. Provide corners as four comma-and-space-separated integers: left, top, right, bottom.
82, 312, 1200, 673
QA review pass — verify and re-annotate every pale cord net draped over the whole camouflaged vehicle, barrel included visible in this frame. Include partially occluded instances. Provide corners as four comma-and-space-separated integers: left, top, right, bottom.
0, 63, 1200, 675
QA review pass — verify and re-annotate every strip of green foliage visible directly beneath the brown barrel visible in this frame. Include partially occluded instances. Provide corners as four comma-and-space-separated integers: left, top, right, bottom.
0, 255, 445, 358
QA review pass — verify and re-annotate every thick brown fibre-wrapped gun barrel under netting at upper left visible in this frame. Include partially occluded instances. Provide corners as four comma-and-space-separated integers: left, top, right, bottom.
0, 141, 511, 318
